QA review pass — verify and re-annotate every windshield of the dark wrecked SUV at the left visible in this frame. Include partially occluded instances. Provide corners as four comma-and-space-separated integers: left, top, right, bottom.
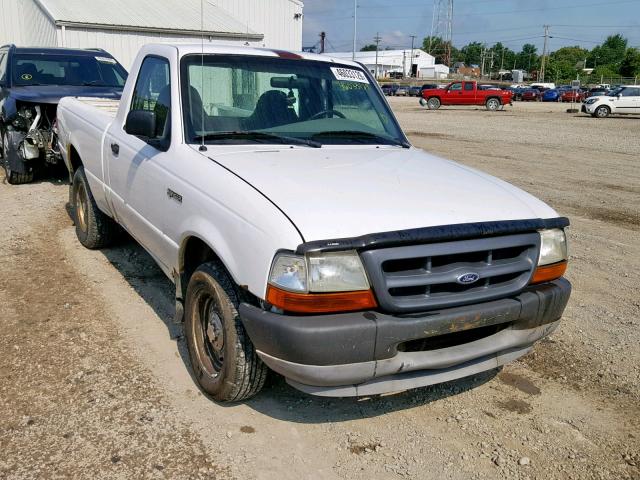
12, 52, 127, 88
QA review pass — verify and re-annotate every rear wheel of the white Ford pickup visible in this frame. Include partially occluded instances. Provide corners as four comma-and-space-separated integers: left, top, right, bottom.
71, 167, 118, 250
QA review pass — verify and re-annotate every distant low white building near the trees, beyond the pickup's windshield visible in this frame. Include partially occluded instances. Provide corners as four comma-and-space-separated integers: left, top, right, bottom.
327, 48, 449, 77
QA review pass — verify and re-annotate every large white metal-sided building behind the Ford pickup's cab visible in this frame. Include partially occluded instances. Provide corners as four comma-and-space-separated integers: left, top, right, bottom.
0, 0, 303, 68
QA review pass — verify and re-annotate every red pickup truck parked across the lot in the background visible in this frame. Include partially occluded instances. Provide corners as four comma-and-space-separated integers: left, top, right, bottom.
420, 82, 513, 111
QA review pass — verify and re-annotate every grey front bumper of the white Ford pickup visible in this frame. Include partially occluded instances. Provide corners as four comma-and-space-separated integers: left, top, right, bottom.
240, 279, 571, 397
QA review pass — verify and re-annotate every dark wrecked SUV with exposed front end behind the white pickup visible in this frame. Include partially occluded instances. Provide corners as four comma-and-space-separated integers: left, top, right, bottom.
0, 45, 127, 184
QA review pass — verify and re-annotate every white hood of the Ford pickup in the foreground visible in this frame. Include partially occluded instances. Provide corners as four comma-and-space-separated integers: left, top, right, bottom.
212, 146, 557, 241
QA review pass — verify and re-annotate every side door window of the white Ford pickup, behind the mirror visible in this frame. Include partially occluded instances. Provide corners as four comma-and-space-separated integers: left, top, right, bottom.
131, 57, 171, 142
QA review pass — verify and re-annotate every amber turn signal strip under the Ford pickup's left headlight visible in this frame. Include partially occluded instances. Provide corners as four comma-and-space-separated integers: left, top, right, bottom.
266, 285, 378, 313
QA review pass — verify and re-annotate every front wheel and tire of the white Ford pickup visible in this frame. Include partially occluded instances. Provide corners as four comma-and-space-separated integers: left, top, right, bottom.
184, 262, 267, 402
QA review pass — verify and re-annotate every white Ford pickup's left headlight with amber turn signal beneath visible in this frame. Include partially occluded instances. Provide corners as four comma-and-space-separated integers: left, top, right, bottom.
266, 251, 377, 313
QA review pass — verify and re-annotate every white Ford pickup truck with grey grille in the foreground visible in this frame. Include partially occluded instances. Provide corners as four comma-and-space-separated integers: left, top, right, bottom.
58, 45, 571, 401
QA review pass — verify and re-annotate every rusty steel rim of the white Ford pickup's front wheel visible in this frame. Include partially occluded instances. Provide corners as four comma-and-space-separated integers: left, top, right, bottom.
193, 293, 224, 378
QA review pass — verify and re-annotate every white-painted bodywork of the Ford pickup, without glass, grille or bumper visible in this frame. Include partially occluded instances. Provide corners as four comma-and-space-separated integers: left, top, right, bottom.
58, 45, 557, 298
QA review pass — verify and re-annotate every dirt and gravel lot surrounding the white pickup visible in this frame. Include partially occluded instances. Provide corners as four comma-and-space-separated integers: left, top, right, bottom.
0, 98, 640, 480
